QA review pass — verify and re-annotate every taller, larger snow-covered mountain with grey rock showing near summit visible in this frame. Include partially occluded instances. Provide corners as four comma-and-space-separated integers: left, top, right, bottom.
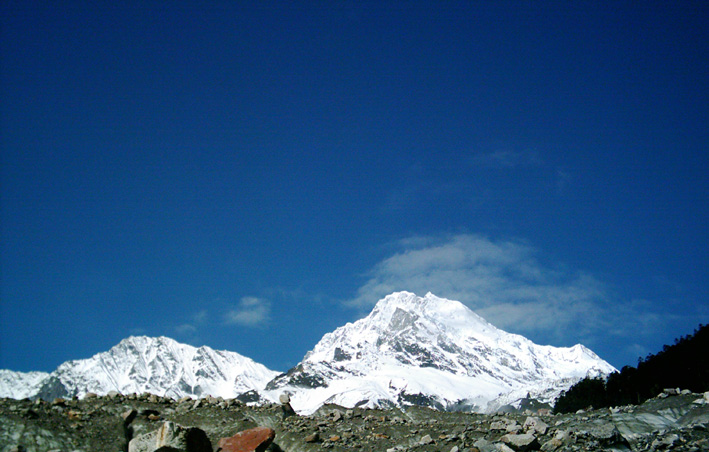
264, 292, 615, 414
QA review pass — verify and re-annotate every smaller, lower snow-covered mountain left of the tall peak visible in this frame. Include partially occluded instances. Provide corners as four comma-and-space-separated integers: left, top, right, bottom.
1, 336, 278, 400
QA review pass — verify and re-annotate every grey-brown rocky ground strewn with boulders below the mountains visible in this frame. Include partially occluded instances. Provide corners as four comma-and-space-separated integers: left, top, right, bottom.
0, 390, 709, 452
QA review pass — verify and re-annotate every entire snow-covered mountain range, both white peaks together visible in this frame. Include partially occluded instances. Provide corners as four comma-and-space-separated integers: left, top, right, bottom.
0, 292, 615, 414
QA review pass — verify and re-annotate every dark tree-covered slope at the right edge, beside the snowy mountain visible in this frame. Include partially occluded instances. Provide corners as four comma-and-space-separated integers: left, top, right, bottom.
554, 325, 709, 413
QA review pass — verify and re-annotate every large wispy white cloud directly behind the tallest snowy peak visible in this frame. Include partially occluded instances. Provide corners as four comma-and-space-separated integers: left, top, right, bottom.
347, 235, 612, 341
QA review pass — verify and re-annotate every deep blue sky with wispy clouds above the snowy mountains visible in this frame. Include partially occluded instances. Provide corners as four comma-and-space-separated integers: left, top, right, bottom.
0, 0, 709, 371
